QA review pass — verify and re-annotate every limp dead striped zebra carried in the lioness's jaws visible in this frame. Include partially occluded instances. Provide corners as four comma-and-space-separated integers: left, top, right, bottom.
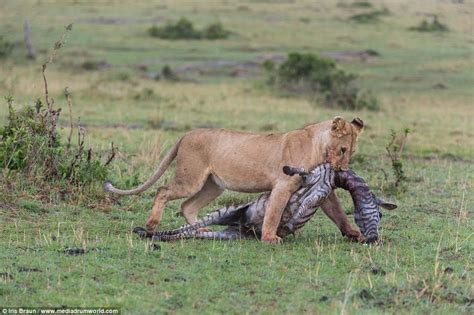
133, 163, 397, 243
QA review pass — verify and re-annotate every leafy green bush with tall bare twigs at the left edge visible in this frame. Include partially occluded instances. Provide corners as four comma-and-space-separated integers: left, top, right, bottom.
0, 26, 115, 194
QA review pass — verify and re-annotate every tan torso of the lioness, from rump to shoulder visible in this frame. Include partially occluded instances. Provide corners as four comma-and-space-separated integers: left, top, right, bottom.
177, 129, 318, 192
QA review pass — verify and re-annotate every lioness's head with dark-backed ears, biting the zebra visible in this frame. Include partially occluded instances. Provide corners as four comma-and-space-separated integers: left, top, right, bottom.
327, 117, 364, 171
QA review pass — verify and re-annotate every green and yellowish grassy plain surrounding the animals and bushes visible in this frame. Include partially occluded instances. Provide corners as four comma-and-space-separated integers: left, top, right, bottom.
0, 0, 474, 314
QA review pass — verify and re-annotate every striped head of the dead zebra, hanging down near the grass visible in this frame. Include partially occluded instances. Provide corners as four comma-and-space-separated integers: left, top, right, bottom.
354, 193, 397, 244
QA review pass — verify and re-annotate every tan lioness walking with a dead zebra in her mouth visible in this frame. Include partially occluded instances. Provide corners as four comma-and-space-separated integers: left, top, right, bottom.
104, 117, 364, 243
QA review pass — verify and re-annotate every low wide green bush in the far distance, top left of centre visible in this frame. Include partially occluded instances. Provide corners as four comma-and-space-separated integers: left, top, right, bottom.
148, 17, 230, 40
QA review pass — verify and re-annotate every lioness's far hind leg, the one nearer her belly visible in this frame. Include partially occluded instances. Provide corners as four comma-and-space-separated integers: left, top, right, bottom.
181, 176, 224, 224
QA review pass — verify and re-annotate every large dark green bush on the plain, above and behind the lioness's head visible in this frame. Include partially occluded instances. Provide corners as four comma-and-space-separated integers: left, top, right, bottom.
263, 53, 379, 110
